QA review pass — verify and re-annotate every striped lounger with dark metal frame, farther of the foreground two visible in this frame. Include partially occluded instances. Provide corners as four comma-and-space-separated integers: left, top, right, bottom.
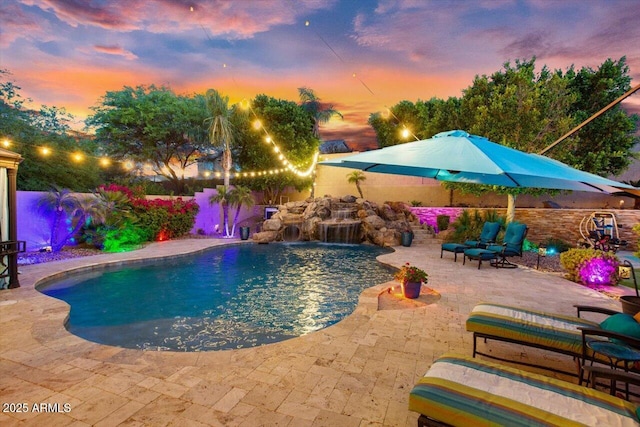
466, 303, 640, 377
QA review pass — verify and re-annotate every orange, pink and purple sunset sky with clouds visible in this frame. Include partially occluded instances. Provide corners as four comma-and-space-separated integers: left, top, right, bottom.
0, 0, 640, 151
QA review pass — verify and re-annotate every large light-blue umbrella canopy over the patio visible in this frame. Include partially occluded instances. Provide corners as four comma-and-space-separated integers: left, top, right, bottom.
320, 130, 640, 196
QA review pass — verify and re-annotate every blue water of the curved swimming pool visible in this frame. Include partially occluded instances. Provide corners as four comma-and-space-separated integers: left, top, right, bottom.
39, 243, 393, 351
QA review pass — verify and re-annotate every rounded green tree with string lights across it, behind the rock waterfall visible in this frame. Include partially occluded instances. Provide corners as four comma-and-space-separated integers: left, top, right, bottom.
234, 95, 320, 204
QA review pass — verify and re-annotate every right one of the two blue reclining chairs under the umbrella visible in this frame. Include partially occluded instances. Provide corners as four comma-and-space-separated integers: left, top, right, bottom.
462, 222, 529, 269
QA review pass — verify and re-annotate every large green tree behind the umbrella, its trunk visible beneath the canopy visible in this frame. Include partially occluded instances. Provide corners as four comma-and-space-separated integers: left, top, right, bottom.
458, 58, 575, 222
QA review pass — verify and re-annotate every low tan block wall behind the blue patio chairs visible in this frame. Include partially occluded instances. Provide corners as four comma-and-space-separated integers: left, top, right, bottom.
412, 207, 640, 252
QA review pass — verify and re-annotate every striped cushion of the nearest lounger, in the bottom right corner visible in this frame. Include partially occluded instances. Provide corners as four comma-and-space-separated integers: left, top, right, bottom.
409, 354, 638, 426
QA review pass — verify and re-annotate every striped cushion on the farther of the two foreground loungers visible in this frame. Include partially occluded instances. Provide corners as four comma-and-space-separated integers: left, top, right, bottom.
467, 303, 599, 355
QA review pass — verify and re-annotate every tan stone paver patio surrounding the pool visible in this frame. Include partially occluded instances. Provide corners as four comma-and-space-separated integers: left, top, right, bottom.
0, 239, 632, 426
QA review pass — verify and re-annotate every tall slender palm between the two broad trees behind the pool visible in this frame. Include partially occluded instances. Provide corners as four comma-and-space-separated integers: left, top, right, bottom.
206, 89, 235, 188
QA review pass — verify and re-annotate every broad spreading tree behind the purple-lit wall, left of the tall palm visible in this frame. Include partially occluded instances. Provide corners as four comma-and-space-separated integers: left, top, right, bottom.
86, 85, 207, 194
